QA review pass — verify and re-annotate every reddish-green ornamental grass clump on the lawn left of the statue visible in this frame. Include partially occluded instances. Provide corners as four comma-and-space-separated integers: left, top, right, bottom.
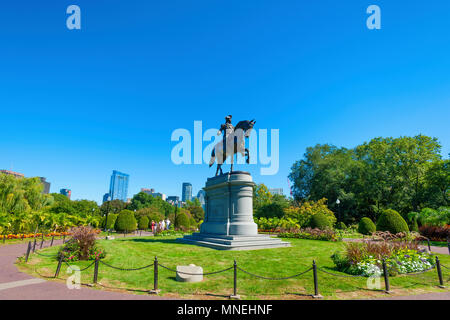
58, 226, 105, 261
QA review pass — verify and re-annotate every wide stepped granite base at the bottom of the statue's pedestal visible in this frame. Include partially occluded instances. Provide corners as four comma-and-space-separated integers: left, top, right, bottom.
177, 233, 291, 250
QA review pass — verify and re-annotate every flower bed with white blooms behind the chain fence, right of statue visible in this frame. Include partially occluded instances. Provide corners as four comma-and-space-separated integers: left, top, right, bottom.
331, 241, 434, 277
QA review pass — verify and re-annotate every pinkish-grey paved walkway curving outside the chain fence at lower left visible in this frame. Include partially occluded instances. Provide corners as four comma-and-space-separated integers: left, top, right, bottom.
0, 236, 176, 300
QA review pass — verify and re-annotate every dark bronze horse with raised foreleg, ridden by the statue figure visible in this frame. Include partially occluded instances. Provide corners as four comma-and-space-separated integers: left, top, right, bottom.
209, 120, 256, 176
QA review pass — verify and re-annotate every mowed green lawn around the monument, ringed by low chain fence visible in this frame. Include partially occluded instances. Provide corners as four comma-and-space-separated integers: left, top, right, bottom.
18, 237, 450, 299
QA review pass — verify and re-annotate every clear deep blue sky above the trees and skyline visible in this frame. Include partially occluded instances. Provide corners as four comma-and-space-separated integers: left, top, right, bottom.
0, 0, 450, 202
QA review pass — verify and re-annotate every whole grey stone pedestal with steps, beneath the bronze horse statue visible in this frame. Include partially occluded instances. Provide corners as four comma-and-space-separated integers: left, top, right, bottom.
177, 171, 290, 250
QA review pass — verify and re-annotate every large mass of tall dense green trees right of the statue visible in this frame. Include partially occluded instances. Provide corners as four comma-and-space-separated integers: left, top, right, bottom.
289, 135, 450, 222
